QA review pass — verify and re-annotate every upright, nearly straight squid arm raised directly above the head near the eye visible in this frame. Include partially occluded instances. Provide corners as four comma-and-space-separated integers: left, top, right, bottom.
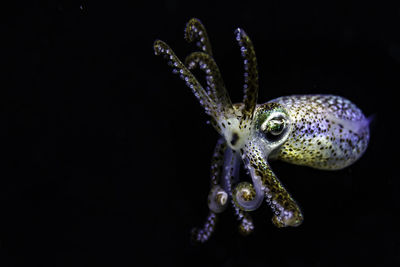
235, 28, 258, 118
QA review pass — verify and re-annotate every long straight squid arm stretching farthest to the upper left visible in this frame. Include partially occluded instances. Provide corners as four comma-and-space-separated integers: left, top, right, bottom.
154, 40, 218, 119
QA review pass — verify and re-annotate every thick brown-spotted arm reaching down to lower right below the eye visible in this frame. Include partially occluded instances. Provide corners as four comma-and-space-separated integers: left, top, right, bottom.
244, 142, 303, 227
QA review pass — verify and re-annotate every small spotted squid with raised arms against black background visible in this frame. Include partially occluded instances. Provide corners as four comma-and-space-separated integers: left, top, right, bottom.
154, 18, 370, 242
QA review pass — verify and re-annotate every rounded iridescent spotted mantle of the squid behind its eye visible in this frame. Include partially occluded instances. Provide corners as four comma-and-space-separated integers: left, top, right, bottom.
271, 95, 369, 170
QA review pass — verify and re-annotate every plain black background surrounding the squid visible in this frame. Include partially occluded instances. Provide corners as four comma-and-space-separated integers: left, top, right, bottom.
0, 0, 400, 266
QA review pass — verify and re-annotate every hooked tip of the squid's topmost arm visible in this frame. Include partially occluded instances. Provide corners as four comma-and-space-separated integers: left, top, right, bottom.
185, 18, 212, 56
